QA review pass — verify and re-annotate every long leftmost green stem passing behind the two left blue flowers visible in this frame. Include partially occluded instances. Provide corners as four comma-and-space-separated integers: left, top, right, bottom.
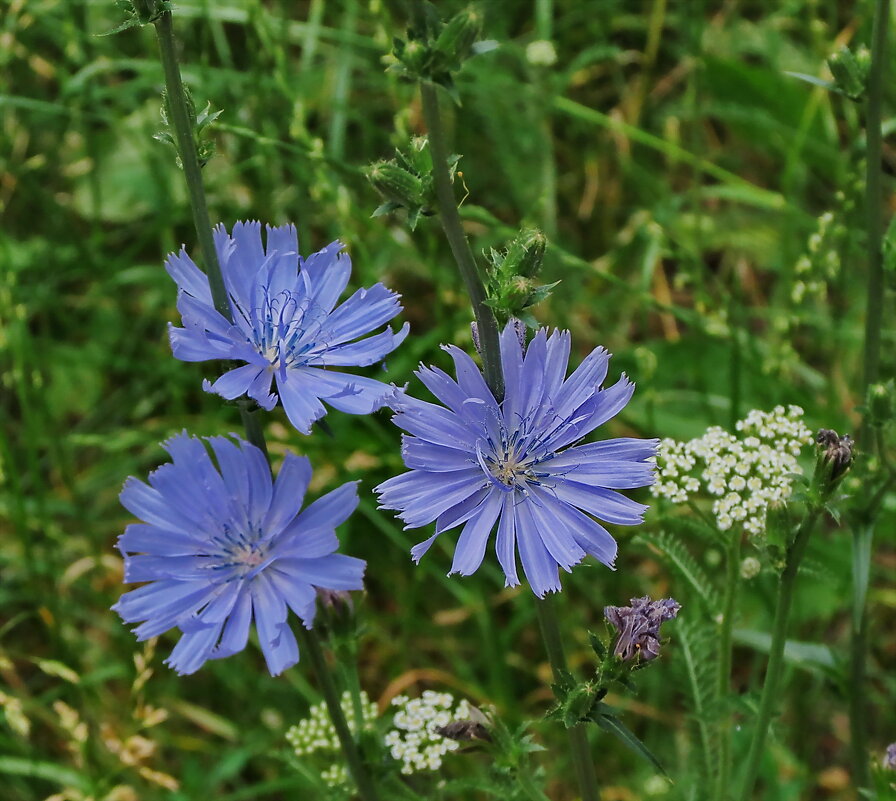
154, 10, 377, 801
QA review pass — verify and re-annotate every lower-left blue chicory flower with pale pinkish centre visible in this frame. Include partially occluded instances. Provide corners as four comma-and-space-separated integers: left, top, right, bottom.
112, 432, 365, 675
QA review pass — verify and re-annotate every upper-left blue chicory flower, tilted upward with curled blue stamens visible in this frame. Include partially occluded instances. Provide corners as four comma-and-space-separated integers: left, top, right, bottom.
165, 222, 408, 434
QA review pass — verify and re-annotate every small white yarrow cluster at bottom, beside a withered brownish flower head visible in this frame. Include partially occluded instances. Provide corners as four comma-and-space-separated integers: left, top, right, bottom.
384, 690, 471, 775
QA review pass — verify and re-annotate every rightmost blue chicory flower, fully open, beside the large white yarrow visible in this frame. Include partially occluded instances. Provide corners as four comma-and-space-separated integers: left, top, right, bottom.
376, 324, 657, 597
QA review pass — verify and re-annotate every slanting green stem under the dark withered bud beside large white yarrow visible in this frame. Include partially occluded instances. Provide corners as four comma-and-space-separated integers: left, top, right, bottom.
739, 506, 821, 801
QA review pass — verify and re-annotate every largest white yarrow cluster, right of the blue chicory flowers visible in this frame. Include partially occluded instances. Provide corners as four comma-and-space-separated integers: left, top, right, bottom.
651, 406, 812, 535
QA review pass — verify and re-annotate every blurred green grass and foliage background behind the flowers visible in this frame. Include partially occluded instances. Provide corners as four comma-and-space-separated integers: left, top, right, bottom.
0, 0, 896, 801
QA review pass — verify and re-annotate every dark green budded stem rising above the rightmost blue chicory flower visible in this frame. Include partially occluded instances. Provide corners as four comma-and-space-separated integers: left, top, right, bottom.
420, 82, 504, 403
